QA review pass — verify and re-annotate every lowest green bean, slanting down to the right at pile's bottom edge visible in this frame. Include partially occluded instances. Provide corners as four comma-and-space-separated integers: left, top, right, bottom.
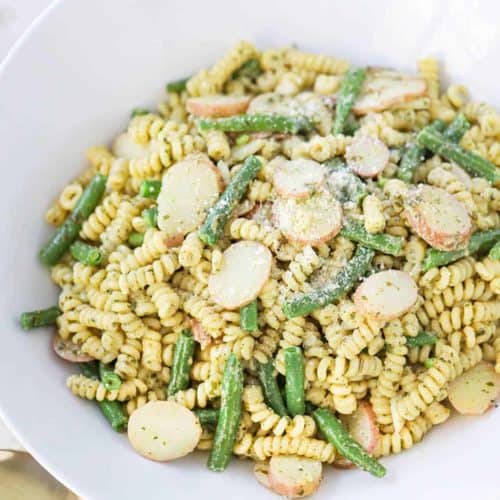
313, 408, 387, 477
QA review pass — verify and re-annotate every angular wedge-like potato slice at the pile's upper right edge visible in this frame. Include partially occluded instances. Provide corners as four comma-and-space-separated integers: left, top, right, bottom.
352, 69, 427, 115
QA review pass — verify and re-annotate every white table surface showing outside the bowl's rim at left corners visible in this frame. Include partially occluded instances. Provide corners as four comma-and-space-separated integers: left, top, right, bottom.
0, 0, 52, 449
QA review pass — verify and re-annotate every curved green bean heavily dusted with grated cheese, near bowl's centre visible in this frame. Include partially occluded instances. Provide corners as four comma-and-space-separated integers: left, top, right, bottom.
283, 245, 375, 318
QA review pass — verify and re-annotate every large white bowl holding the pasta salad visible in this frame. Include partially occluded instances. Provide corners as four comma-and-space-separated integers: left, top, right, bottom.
0, 0, 500, 500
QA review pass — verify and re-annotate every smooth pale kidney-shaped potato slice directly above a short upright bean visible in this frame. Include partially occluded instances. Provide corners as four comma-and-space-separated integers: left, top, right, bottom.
208, 241, 273, 309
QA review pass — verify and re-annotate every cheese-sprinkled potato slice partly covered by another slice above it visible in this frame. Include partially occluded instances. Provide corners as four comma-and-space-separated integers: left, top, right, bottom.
273, 190, 342, 246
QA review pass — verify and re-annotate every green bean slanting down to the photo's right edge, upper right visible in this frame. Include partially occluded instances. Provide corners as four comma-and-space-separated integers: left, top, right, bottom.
417, 127, 500, 184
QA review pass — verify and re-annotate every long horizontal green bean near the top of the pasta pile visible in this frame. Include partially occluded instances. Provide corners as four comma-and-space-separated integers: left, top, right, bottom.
198, 115, 314, 134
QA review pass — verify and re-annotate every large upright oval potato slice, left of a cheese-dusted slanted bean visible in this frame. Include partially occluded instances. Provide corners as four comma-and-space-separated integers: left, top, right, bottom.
158, 154, 224, 238
